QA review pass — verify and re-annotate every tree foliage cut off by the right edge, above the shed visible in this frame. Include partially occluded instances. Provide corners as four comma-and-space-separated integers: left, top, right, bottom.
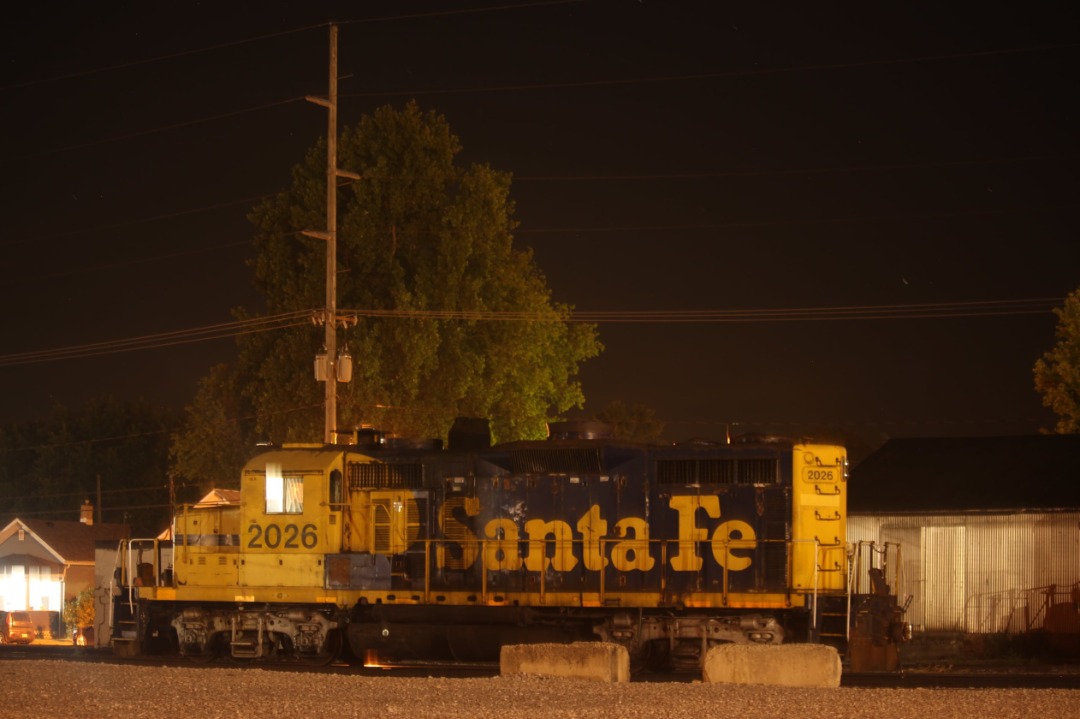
1035, 289, 1080, 434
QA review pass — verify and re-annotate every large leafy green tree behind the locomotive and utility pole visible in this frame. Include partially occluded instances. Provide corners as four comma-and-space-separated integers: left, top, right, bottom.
174, 103, 600, 472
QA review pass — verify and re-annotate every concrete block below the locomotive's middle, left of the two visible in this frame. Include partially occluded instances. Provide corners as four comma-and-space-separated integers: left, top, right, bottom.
499, 641, 630, 683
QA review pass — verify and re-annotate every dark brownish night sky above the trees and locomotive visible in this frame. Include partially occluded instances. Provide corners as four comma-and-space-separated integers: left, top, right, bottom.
0, 0, 1080, 448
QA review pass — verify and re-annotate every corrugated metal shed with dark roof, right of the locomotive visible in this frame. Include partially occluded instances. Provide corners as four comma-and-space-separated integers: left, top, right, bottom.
848, 435, 1080, 638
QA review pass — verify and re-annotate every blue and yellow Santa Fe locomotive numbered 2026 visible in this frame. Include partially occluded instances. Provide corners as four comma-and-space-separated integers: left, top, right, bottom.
111, 419, 904, 670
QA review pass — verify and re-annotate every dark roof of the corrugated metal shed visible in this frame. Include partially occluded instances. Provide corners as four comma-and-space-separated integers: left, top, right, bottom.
848, 435, 1080, 514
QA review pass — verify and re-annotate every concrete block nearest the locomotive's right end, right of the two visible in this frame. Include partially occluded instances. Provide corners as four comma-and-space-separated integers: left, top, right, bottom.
702, 645, 842, 688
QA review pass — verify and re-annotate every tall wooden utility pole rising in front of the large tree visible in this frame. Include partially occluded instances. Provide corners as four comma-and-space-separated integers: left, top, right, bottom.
303, 25, 360, 445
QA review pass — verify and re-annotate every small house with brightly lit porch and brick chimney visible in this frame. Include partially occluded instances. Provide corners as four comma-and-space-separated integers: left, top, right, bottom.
0, 507, 130, 632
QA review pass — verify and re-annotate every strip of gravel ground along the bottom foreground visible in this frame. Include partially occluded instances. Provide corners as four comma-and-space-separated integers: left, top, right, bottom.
0, 660, 1080, 719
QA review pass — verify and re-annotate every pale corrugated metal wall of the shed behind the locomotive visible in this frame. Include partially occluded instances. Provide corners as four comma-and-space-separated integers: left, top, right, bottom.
848, 512, 1080, 634
